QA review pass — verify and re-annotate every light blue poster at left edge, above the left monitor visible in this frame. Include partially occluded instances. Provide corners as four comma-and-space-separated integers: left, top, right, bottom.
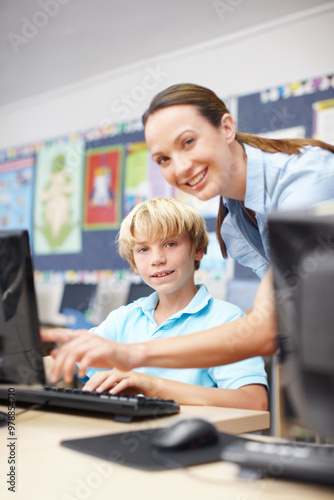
0, 156, 35, 234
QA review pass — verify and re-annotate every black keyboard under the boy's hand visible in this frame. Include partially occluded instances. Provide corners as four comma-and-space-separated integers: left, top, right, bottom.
0, 386, 180, 422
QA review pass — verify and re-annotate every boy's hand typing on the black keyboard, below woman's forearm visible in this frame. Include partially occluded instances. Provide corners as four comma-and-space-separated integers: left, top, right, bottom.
83, 368, 157, 397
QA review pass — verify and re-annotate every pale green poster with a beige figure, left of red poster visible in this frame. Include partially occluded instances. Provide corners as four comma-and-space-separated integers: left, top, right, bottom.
34, 140, 85, 255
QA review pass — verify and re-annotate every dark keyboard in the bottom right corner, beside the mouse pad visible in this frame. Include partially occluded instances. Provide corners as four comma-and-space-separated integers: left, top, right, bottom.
221, 439, 334, 485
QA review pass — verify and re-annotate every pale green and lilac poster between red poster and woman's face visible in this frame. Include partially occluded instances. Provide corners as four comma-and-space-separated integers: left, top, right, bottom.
124, 142, 173, 215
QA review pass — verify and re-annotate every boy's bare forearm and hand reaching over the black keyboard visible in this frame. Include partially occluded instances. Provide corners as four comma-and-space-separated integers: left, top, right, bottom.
84, 369, 268, 411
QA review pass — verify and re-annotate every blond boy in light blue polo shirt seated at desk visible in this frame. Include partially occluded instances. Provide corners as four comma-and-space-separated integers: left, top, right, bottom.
47, 198, 267, 410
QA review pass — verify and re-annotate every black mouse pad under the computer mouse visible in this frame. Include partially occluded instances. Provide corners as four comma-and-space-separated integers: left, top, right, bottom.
61, 429, 244, 471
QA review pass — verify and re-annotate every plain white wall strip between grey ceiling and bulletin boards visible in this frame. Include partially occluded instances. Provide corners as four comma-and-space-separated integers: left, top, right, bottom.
0, 2, 334, 149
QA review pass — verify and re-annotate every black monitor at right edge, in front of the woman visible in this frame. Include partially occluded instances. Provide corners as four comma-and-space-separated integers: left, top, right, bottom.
268, 210, 334, 438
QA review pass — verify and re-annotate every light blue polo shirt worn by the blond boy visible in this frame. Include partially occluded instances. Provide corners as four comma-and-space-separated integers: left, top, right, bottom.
87, 285, 268, 389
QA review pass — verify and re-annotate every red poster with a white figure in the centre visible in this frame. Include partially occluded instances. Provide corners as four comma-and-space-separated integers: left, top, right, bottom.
83, 145, 124, 230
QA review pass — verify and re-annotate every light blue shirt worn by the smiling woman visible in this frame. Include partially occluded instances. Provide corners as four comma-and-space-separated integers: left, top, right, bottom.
221, 144, 334, 278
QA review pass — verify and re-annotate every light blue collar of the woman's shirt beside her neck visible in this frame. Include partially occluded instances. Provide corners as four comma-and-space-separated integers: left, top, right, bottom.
243, 144, 265, 213
